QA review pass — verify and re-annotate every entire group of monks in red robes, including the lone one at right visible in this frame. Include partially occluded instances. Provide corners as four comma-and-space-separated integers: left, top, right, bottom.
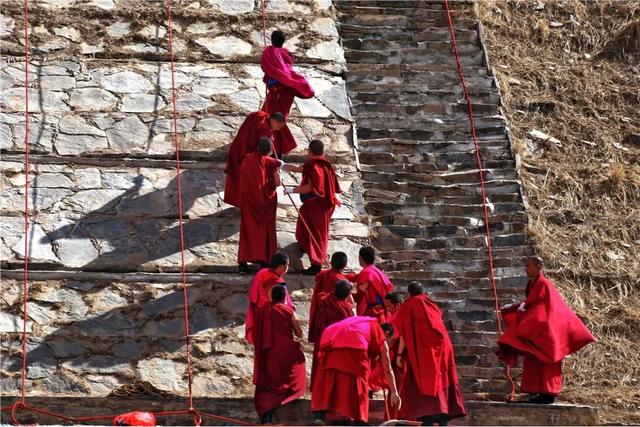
224, 31, 595, 425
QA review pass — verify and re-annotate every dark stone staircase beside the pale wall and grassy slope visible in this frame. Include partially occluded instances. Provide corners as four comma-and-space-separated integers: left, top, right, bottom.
335, 1, 531, 400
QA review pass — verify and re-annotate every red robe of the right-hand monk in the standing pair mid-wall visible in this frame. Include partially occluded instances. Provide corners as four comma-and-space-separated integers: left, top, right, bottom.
296, 156, 342, 265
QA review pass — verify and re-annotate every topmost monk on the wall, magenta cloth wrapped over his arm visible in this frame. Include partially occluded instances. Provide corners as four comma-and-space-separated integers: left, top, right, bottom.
260, 31, 314, 118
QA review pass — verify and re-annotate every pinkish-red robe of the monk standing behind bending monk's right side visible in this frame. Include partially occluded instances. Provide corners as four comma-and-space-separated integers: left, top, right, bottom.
356, 264, 393, 323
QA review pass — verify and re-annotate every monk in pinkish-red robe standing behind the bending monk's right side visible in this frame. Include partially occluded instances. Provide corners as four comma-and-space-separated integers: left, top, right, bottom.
356, 246, 393, 323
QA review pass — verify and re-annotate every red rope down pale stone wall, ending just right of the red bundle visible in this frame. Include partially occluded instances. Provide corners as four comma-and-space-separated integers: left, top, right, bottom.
167, 0, 193, 409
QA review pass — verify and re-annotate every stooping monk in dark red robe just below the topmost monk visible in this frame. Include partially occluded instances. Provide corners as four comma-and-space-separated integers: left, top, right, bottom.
224, 111, 297, 207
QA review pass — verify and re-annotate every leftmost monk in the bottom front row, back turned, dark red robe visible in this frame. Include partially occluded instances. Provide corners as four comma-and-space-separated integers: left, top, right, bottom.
253, 285, 307, 424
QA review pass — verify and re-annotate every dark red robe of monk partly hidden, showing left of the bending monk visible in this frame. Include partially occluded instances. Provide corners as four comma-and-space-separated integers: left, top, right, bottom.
309, 293, 353, 387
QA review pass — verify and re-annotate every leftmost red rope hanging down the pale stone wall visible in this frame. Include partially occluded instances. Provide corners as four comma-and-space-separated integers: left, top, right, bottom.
20, 0, 30, 405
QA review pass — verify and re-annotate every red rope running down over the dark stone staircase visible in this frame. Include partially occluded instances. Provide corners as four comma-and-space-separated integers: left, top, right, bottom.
444, 0, 515, 400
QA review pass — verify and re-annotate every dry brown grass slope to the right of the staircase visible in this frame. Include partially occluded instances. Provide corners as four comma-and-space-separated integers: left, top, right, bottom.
479, 0, 640, 423
